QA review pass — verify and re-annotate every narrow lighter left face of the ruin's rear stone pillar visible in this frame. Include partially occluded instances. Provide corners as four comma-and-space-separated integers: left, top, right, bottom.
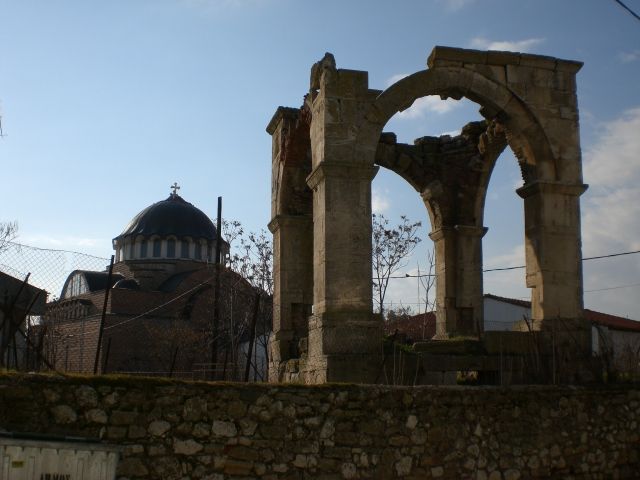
429, 227, 458, 339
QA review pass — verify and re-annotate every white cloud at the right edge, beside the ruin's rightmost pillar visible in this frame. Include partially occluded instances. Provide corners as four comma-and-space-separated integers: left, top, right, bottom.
582, 107, 640, 320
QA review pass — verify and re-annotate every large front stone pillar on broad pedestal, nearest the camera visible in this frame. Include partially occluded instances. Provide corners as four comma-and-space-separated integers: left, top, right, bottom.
306, 162, 382, 383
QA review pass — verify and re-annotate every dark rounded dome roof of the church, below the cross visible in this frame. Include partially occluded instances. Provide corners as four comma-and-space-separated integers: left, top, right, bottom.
114, 193, 216, 240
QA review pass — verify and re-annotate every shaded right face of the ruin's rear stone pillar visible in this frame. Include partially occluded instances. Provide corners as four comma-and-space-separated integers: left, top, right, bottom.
455, 225, 487, 336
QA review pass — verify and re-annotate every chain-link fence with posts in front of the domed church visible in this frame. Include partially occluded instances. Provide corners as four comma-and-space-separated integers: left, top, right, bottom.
0, 242, 272, 381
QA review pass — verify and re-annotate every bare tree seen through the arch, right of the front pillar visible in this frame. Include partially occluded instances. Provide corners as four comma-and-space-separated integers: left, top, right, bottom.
371, 213, 422, 315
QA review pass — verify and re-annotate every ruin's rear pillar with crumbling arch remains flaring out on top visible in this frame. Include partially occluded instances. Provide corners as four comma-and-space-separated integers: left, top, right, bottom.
375, 121, 506, 337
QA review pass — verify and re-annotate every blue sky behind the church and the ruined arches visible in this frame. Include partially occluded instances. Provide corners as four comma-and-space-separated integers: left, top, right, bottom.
0, 0, 640, 319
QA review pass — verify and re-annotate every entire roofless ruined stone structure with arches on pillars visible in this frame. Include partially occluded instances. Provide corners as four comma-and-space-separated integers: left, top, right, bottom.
267, 47, 588, 383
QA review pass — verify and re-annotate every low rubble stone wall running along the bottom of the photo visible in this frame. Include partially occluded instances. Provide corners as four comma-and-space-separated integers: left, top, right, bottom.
0, 375, 640, 480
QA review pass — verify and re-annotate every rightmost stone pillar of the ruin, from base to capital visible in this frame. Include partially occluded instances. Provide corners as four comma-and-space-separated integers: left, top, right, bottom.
517, 182, 588, 341
